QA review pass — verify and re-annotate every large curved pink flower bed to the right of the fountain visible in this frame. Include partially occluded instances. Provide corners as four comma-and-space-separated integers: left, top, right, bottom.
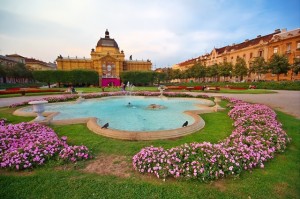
132, 98, 290, 181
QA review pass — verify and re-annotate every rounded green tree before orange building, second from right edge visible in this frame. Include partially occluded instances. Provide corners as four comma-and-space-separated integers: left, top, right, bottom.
268, 54, 290, 81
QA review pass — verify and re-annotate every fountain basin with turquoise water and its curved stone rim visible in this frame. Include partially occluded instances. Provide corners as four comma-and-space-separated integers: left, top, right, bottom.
14, 96, 213, 140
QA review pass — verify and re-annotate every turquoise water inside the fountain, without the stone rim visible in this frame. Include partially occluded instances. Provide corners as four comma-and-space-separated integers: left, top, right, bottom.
19, 96, 212, 132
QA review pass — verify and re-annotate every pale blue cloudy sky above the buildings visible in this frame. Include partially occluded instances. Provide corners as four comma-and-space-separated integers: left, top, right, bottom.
0, 0, 300, 69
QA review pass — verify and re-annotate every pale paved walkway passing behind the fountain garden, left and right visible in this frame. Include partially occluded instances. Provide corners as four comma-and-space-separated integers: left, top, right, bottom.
0, 90, 300, 119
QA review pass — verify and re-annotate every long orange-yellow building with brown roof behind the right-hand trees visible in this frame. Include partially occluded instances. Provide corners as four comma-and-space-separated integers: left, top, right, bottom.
172, 28, 300, 81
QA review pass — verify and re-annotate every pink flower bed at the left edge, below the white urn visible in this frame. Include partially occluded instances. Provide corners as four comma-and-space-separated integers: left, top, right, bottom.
0, 120, 92, 170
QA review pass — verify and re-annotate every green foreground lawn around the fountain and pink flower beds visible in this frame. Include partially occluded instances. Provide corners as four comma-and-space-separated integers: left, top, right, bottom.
0, 102, 300, 199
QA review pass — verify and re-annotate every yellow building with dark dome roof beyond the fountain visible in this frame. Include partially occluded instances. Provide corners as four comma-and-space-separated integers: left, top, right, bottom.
56, 30, 152, 86
